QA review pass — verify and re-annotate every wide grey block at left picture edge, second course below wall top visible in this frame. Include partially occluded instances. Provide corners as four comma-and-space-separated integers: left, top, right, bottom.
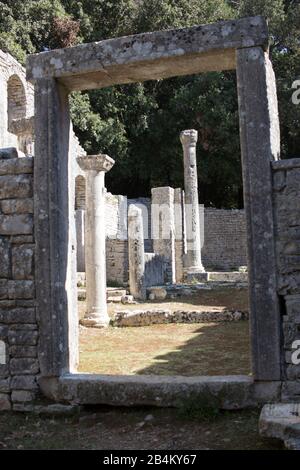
0, 175, 32, 199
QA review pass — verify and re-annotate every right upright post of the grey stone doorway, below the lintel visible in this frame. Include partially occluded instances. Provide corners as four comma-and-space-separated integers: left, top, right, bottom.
237, 47, 281, 380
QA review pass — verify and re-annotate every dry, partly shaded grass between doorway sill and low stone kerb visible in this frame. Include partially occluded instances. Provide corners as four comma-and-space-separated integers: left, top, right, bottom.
79, 321, 250, 375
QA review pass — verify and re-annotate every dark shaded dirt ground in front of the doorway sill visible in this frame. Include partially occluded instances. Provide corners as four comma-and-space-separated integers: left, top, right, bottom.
0, 409, 282, 450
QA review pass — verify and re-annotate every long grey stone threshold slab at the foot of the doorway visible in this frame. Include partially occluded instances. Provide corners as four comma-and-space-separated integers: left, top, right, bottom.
39, 374, 281, 410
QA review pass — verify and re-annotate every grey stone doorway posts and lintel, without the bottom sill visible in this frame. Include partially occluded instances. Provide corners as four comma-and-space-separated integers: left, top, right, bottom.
27, 13, 281, 396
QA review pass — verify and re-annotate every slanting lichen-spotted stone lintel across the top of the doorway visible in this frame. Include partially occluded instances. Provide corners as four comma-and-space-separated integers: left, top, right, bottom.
27, 16, 268, 90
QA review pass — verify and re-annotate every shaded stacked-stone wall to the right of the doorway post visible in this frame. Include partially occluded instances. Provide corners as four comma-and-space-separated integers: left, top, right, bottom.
273, 159, 300, 401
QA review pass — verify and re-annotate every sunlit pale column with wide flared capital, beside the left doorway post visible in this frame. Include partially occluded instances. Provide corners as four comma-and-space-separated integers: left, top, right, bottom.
77, 155, 115, 328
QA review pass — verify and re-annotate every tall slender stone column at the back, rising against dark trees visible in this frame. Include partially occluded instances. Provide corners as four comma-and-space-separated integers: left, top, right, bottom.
180, 129, 205, 277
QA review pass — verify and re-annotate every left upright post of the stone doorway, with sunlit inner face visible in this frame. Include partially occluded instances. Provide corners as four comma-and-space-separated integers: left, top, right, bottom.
34, 79, 78, 376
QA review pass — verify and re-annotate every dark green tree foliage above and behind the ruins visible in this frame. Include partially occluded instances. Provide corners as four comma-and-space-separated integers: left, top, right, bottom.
0, 0, 300, 208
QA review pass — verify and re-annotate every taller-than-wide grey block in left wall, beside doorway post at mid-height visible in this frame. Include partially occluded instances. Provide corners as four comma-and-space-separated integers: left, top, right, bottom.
12, 245, 34, 279
